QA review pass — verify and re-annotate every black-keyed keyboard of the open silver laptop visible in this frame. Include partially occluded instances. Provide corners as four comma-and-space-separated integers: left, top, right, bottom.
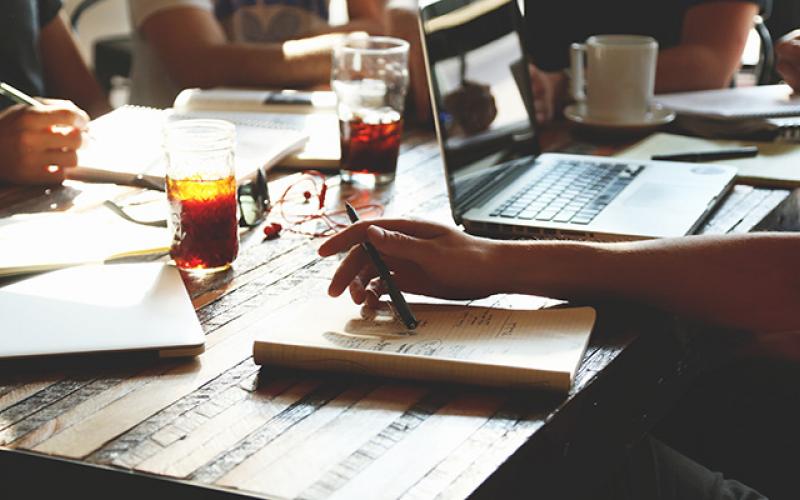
489, 160, 644, 224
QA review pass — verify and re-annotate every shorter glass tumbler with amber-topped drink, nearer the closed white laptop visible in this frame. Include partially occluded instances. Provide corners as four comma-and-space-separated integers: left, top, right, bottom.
164, 120, 239, 272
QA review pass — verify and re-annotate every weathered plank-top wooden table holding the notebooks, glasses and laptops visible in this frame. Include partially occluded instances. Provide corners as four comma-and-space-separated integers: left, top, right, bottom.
0, 128, 800, 499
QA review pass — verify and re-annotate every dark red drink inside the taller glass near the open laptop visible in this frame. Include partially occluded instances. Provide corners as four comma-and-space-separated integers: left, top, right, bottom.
339, 109, 403, 183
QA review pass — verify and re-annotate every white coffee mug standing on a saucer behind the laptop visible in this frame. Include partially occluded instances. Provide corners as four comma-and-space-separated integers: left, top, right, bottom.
570, 35, 658, 124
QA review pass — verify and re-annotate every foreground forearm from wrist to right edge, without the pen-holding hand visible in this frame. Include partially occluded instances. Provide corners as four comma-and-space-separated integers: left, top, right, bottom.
494, 233, 800, 332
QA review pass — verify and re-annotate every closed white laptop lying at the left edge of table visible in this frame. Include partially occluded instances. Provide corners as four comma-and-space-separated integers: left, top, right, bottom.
0, 263, 205, 359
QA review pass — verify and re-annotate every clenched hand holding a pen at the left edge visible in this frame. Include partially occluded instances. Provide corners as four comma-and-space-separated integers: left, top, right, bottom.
0, 101, 89, 184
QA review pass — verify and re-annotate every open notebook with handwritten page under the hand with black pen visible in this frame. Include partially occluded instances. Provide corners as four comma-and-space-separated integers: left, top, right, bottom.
253, 298, 595, 392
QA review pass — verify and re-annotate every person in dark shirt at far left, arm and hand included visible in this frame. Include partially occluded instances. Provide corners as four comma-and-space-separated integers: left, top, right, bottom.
0, 0, 109, 184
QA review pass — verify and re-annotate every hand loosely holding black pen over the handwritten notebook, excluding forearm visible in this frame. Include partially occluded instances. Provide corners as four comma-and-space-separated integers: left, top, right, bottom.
319, 219, 500, 306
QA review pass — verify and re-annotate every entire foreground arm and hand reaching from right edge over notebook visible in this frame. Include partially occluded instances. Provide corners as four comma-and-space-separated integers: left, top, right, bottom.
319, 220, 800, 333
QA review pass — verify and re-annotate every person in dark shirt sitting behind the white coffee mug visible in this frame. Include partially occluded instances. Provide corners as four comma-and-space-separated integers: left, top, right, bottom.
525, 0, 769, 121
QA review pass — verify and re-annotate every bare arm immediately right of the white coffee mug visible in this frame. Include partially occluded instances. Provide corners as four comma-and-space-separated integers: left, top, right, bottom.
656, 2, 758, 93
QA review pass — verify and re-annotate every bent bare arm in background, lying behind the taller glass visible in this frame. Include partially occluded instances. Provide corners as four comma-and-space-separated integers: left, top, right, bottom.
140, 7, 341, 87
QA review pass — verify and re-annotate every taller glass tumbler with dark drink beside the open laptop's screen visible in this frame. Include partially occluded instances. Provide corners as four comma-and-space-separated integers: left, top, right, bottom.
331, 35, 409, 184
